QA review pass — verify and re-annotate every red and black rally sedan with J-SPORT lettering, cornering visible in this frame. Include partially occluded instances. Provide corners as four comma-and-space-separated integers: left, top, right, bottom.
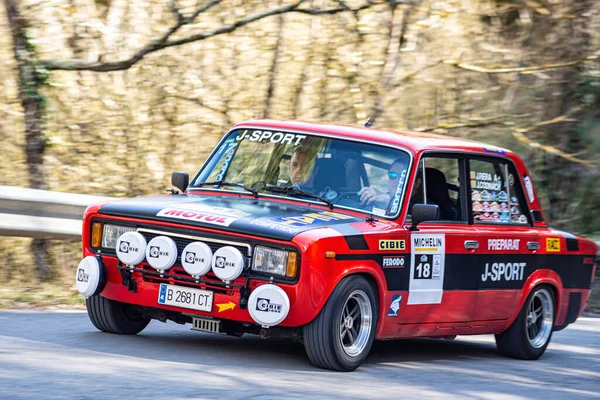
76, 120, 597, 371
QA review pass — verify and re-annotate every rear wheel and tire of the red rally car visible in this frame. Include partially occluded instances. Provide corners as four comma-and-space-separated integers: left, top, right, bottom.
496, 285, 556, 360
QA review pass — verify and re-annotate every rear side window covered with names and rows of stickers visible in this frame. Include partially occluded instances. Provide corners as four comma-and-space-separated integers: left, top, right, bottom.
469, 160, 529, 225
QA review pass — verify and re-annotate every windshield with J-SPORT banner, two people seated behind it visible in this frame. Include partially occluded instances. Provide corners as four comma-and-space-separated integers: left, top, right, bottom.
190, 129, 410, 216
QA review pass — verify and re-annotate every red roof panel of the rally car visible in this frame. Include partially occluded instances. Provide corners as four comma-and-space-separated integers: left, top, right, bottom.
234, 119, 512, 156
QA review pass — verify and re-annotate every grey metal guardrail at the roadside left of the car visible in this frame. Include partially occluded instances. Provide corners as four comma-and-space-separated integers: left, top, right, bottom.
0, 186, 116, 239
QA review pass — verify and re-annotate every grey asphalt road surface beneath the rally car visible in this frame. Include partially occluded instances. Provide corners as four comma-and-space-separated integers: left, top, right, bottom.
0, 311, 600, 400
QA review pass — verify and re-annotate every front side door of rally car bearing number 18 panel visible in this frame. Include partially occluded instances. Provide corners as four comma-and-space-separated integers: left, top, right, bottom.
400, 154, 478, 323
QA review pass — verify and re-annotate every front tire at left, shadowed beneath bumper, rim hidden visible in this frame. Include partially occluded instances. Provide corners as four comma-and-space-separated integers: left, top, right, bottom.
85, 296, 150, 335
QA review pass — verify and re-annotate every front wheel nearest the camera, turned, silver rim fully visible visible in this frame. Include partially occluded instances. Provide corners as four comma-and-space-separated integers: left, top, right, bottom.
303, 275, 379, 371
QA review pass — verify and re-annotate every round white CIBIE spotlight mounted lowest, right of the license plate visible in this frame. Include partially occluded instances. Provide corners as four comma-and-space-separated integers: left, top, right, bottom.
248, 283, 290, 327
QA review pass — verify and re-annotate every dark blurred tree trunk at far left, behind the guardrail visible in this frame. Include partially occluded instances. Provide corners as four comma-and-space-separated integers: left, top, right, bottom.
4, 0, 50, 279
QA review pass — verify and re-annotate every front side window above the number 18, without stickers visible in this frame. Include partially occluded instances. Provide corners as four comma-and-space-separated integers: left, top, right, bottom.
409, 156, 467, 222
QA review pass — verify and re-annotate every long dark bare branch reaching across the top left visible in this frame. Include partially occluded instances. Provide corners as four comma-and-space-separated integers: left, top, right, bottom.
41, 0, 404, 72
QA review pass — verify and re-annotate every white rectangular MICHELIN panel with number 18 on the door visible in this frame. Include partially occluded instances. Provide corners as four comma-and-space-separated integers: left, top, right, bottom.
407, 234, 446, 305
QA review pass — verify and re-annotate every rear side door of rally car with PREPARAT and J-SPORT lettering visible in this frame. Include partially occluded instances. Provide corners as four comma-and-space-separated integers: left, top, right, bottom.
468, 156, 540, 321
